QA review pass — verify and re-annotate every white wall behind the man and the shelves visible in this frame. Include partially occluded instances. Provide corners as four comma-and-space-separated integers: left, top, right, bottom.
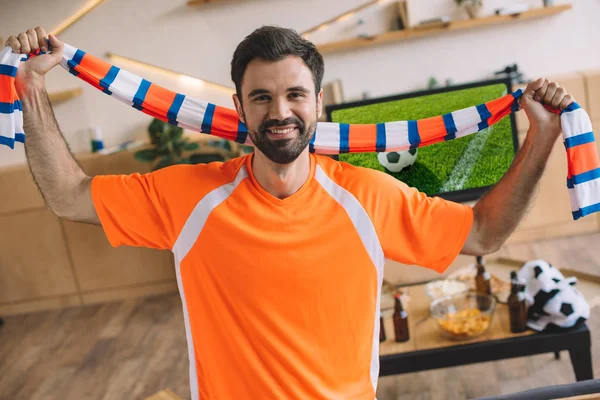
0, 0, 600, 165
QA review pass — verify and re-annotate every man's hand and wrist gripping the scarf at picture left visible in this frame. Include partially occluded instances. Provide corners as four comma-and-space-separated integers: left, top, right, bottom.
6, 27, 64, 96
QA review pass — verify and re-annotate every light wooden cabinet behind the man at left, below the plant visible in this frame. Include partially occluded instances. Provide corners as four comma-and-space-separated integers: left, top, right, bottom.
0, 152, 177, 316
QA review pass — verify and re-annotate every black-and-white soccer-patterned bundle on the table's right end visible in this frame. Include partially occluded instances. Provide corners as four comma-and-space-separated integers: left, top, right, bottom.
518, 260, 590, 331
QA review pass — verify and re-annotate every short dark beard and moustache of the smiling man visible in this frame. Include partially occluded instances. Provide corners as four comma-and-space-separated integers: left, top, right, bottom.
248, 112, 317, 165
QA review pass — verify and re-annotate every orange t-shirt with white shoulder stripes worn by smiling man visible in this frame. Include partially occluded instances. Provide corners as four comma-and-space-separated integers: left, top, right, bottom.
92, 155, 473, 399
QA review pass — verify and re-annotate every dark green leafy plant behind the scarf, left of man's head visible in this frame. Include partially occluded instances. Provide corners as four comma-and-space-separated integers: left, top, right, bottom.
135, 118, 231, 171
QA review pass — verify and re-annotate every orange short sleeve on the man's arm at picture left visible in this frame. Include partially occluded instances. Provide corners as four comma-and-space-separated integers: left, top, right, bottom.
92, 171, 175, 249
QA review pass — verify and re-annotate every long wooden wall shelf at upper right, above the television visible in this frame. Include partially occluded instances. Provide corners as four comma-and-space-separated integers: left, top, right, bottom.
317, 4, 573, 54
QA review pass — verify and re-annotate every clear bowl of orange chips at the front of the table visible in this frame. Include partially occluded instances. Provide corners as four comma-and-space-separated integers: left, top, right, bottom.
429, 292, 496, 340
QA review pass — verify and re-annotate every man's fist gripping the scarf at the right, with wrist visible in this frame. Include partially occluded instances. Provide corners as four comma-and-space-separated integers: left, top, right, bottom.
521, 78, 575, 143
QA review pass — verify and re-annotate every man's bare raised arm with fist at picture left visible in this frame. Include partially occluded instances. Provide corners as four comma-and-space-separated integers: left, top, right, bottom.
6, 27, 100, 224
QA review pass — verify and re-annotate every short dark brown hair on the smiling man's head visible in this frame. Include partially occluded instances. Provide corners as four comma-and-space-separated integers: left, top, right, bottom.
231, 26, 325, 101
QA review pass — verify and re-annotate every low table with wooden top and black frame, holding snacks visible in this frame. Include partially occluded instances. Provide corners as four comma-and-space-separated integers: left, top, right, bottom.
379, 285, 593, 381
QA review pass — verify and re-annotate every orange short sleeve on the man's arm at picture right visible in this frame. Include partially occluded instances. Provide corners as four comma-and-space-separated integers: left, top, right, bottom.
374, 170, 473, 273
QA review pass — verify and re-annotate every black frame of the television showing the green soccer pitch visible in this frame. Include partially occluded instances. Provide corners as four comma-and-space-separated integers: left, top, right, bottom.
325, 78, 519, 203
